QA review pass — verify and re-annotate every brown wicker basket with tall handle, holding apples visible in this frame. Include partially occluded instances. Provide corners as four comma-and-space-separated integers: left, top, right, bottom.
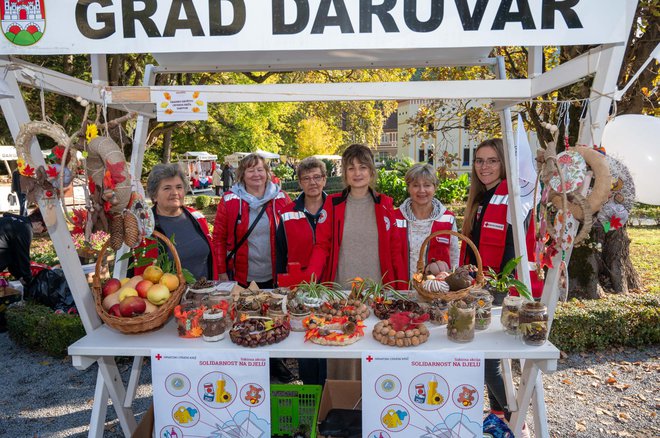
92, 231, 186, 334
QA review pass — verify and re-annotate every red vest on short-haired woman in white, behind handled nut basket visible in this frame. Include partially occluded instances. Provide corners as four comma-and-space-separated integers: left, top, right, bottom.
394, 208, 456, 278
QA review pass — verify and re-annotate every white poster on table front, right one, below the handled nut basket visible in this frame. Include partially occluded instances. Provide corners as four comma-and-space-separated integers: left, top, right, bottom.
362, 351, 484, 438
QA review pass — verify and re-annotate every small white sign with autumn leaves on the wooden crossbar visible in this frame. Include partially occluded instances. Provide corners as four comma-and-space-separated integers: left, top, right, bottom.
151, 90, 209, 122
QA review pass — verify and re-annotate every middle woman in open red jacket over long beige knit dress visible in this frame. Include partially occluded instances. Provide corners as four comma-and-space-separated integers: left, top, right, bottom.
305, 144, 407, 380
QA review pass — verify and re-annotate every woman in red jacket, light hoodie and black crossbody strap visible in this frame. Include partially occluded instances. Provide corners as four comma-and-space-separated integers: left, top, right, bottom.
213, 154, 291, 289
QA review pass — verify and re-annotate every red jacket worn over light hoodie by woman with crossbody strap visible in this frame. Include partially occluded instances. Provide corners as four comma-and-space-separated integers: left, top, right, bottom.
213, 191, 291, 286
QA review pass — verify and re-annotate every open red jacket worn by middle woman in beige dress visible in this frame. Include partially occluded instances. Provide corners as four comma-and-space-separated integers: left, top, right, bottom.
307, 189, 408, 289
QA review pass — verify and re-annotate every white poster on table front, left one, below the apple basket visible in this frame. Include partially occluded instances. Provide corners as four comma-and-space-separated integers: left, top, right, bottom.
151, 349, 270, 438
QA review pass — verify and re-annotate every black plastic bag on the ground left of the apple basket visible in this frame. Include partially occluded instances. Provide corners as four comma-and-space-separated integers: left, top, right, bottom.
23, 269, 75, 312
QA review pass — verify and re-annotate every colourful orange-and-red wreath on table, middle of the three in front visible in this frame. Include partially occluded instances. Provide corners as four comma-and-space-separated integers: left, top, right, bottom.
303, 315, 365, 346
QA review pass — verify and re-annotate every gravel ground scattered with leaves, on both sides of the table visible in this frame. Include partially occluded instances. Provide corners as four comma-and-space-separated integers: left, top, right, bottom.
0, 333, 660, 438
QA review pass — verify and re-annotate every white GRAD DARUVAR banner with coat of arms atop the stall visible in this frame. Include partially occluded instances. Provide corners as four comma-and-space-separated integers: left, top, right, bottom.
0, 0, 637, 55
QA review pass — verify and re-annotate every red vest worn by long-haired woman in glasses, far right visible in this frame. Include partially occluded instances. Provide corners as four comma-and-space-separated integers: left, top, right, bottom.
460, 180, 543, 298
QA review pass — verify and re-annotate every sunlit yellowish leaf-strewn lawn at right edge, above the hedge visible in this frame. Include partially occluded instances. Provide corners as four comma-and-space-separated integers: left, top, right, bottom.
628, 227, 660, 291
